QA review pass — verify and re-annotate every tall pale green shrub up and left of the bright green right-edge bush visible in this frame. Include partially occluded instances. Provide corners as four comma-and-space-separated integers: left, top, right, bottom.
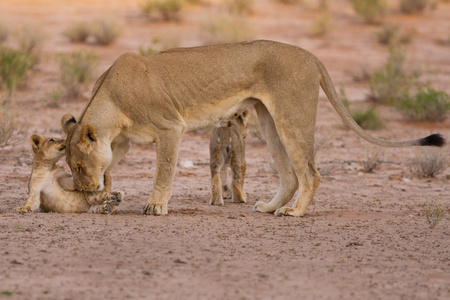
369, 47, 420, 104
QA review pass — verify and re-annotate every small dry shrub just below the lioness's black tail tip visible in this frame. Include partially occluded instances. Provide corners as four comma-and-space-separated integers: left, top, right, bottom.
410, 148, 448, 178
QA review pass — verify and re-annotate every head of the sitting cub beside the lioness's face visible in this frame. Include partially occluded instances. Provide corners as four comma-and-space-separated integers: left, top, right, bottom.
30, 134, 66, 164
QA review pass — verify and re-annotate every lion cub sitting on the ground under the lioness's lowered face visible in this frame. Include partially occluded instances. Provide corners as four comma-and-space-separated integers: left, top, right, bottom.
14, 134, 124, 214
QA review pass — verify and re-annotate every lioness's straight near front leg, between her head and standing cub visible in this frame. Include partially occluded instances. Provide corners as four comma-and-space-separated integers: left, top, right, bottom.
143, 128, 184, 216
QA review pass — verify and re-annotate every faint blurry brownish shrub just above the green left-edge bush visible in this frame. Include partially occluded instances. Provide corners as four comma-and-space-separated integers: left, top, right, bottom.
14, 24, 45, 53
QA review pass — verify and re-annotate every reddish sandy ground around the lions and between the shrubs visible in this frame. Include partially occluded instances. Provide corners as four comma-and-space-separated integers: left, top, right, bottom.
0, 0, 450, 299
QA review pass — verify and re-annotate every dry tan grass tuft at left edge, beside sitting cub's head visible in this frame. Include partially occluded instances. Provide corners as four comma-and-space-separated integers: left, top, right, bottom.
0, 104, 26, 149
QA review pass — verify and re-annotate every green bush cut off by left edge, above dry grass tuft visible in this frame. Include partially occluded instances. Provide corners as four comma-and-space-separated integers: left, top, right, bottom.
0, 47, 34, 101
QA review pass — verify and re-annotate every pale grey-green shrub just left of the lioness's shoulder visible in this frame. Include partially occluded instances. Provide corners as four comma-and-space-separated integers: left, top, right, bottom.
59, 50, 98, 98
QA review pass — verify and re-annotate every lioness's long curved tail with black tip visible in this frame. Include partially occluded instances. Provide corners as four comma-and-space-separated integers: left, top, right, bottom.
317, 61, 445, 147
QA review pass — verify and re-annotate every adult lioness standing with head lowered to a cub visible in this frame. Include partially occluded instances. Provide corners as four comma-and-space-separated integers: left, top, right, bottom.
61, 41, 445, 216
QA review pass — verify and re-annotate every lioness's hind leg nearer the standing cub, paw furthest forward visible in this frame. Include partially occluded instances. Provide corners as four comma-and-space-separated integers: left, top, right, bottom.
253, 103, 298, 213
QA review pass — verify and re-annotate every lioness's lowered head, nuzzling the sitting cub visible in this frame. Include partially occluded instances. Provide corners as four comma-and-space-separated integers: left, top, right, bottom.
61, 114, 112, 192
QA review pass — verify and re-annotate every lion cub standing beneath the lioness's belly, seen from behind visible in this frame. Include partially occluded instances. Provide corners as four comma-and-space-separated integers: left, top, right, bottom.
209, 110, 249, 205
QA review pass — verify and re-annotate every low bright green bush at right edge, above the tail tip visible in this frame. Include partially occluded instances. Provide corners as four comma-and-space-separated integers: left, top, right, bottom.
399, 87, 450, 122
